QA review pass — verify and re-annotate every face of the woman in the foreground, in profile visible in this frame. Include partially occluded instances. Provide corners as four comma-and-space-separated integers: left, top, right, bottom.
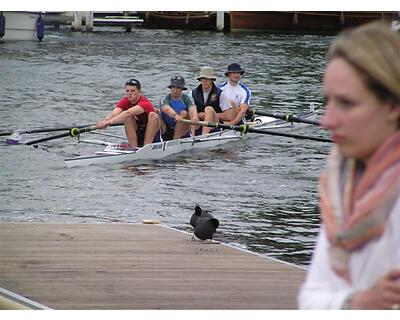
321, 58, 400, 162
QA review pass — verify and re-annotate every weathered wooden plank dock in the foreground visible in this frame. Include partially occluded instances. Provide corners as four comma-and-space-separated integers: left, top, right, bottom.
0, 223, 305, 310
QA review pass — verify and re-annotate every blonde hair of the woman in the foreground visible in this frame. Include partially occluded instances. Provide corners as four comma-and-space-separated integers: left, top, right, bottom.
328, 21, 400, 103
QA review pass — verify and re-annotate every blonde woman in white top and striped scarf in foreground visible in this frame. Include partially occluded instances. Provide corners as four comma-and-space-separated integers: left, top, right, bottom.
299, 23, 400, 309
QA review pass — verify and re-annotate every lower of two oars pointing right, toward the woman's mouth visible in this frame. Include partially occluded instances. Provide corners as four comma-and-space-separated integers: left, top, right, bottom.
182, 119, 333, 142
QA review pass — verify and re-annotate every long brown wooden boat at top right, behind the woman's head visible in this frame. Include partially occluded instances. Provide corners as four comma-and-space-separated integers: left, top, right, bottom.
230, 11, 397, 33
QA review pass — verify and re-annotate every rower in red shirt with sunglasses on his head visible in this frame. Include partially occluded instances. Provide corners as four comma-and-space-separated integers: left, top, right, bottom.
96, 79, 162, 148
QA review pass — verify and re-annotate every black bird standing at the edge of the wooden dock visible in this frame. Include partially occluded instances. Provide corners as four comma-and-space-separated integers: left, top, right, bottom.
190, 205, 219, 240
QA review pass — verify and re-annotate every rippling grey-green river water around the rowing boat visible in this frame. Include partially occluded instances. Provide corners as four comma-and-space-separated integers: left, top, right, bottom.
0, 29, 332, 265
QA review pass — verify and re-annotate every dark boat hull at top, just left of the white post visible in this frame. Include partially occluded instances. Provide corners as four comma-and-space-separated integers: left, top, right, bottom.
143, 11, 222, 31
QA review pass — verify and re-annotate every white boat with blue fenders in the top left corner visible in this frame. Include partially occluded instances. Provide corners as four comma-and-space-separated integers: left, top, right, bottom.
0, 11, 44, 41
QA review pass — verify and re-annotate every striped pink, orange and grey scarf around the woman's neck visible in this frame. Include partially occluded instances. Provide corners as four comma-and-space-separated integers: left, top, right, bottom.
320, 132, 400, 283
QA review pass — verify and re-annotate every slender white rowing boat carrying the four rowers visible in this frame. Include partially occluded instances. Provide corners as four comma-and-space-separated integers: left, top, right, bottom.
65, 108, 317, 168
